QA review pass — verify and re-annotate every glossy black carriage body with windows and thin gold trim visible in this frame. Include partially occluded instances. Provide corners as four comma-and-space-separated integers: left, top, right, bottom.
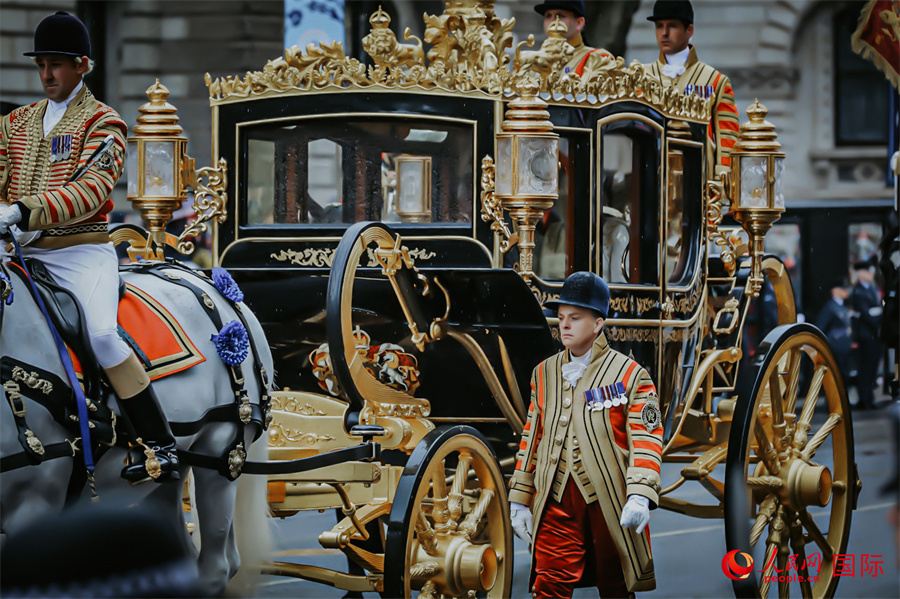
213, 84, 708, 447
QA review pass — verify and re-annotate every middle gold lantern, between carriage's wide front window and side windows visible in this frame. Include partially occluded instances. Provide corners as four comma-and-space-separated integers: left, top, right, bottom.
495, 76, 559, 281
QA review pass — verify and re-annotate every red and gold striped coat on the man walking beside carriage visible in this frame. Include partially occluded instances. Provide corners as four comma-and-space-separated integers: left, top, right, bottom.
509, 333, 663, 592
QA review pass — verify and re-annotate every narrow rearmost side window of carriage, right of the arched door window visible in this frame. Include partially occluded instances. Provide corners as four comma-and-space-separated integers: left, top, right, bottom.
665, 143, 702, 285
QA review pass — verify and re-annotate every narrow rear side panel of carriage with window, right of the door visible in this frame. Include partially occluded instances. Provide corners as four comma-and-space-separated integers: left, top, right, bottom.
656, 121, 706, 426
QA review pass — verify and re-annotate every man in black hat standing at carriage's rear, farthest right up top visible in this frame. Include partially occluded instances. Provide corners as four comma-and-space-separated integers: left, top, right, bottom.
644, 0, 740, 173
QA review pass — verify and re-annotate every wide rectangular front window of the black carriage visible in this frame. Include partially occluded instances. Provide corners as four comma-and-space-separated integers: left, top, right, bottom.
242, 117, 474, 225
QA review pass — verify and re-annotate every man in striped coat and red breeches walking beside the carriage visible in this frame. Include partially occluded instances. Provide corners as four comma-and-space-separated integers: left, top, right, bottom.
509, 272, 663, 597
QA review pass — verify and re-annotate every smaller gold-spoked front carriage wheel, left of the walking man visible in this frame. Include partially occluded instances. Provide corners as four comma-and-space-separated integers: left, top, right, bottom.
384, 426, 513, 599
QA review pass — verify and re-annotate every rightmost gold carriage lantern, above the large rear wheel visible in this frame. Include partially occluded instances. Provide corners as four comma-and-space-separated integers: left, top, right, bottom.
731, 100, 784, 297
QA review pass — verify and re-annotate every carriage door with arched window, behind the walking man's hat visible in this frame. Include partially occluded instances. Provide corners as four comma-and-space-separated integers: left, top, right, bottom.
591, 113, 663, 381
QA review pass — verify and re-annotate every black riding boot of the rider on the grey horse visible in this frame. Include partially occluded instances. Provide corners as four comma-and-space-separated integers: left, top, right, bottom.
119, 385, 180, 483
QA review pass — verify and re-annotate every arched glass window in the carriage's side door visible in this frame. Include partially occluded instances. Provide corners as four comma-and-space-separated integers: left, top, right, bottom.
600, 120, 659, 285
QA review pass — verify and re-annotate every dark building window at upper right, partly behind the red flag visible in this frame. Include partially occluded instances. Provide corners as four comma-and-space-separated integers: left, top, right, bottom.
834, 2, 890, 146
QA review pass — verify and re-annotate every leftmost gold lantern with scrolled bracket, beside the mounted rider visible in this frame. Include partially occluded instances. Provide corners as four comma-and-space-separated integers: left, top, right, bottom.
125, 79, 228, 260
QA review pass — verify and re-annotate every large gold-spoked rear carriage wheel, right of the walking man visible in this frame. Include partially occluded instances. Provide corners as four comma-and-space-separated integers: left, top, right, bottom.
723, 324, 858, 598
